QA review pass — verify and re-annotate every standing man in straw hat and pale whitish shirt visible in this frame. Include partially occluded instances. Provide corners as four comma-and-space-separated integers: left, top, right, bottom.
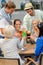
22, 3, 43, 32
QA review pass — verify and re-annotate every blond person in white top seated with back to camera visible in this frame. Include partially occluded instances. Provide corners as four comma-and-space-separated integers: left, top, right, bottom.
0, 25, 24, 65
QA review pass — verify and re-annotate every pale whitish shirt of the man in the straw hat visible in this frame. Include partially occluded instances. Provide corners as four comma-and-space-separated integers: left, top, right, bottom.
22, 10, 43, 32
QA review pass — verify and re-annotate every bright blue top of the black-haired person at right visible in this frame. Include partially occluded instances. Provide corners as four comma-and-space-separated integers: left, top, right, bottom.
35, 36, 43, 56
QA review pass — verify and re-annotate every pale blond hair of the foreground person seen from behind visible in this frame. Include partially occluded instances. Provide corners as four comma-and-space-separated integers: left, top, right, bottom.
3, 25, 15, 38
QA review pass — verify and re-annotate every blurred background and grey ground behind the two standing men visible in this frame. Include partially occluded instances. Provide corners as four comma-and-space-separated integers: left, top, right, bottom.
0, 0, 43, 21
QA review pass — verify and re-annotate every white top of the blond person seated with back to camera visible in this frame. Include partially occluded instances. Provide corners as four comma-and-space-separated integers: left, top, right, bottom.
0, 37, 23, 65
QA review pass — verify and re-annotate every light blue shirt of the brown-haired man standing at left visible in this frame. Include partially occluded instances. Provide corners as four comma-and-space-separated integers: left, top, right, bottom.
0, 7, 11, 24
